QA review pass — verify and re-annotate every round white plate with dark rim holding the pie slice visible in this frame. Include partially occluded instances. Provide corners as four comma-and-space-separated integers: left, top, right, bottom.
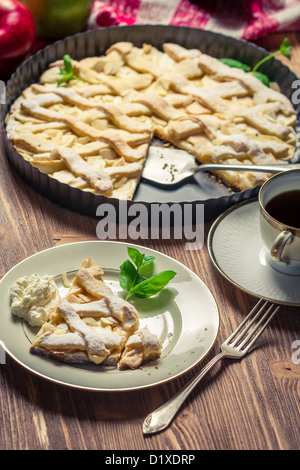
0, 241, 219, 391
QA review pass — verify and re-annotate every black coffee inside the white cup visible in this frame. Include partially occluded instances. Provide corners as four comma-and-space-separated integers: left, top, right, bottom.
265, 189, 300, 228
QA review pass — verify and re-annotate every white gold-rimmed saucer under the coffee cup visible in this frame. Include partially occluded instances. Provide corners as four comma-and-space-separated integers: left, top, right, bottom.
207, 199, 300, 306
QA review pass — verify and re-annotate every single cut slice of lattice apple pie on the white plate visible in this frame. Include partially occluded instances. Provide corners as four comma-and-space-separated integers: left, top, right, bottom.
30, 259, 162, 370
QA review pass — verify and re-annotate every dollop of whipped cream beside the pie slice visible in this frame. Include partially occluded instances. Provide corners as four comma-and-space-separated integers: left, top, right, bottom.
10, 274, 60, 326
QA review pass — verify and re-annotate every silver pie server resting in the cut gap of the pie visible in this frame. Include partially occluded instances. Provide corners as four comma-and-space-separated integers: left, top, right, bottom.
142, 146, 300, 189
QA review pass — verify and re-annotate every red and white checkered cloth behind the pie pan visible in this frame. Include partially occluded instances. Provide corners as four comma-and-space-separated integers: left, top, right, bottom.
88, 0, 300, 41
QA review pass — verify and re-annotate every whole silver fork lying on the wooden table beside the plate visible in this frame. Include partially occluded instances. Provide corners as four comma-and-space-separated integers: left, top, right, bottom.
143, 299, 279, 434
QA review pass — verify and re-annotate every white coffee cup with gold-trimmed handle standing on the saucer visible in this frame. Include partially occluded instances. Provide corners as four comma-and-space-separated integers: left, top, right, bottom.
258, 170, 300, 276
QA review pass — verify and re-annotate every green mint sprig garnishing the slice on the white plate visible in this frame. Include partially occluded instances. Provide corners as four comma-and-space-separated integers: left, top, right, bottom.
119, 247, 176, 300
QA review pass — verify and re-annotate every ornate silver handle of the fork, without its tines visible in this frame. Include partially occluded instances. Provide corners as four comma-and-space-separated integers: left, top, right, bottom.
143, 351, 226, 434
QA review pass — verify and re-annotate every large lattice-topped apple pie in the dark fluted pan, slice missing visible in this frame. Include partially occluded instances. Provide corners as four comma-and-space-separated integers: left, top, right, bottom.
7, 42, 296, 199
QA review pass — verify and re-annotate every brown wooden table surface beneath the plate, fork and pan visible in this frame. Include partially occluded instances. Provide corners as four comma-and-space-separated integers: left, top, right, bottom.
0, 33, 300, 455
